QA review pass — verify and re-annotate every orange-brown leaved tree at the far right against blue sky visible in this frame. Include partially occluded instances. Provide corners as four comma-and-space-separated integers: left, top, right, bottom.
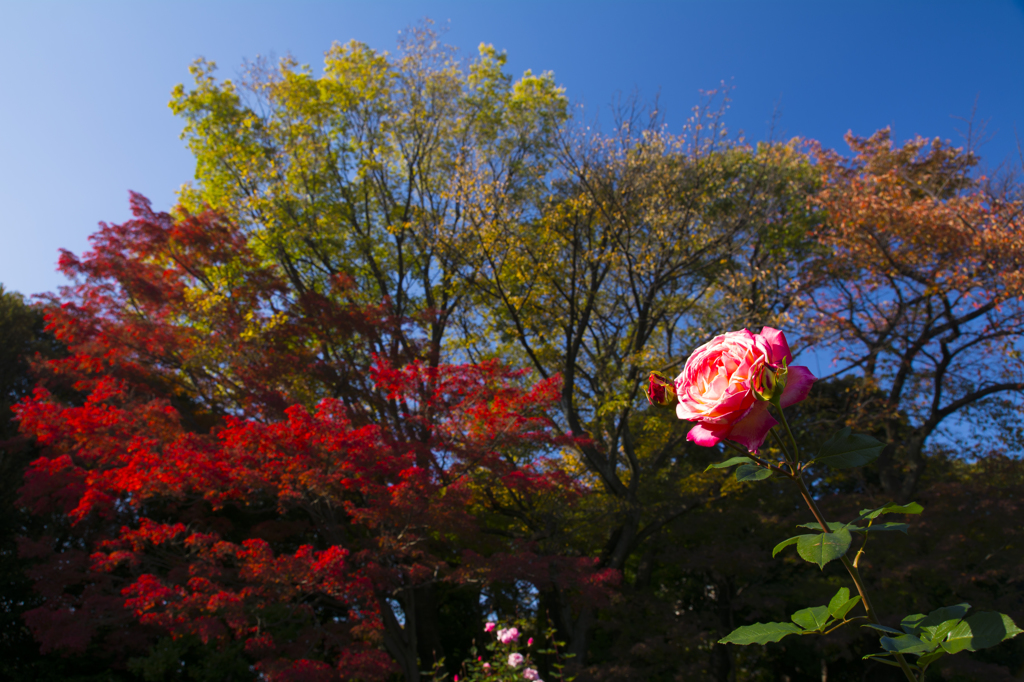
804, 129, 1024, 500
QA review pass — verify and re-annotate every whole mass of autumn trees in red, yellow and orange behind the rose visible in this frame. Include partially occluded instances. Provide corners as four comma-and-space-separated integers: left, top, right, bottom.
6, 29, 1024, 682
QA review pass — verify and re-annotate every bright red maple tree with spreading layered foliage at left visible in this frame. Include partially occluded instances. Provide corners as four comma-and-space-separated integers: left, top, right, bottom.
18, 195, 609, 680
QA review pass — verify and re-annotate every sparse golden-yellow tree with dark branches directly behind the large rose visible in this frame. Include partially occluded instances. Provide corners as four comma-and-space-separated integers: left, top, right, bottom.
451, 93, 814, 662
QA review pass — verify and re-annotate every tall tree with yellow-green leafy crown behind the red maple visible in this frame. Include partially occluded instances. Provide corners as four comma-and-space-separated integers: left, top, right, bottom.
171, 24, 566, 372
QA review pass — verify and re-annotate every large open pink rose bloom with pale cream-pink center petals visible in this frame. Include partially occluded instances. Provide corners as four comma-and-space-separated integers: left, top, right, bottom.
676, 327, 815, 453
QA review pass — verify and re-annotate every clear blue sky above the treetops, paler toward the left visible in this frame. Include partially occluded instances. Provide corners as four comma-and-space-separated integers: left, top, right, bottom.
0, 0, 1024, 294
